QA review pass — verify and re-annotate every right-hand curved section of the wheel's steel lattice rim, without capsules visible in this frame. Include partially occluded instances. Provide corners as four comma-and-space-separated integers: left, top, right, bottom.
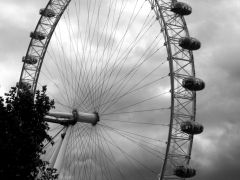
153, 1, 196, 180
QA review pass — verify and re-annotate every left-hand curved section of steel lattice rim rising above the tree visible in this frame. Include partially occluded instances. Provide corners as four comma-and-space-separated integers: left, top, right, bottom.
19, 0, 71, 92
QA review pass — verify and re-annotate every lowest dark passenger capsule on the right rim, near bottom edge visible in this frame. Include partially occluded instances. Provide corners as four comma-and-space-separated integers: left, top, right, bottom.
174, 166, 196, 178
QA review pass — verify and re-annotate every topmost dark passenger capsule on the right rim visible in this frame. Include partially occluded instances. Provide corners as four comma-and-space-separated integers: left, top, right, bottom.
171, 2, 192, 16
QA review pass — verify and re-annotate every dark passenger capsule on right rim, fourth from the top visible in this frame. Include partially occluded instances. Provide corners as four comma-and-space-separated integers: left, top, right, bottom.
180, 121, 203, 135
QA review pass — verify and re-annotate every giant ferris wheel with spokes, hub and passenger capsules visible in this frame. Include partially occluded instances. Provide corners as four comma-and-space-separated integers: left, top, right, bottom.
19, 0, 205, 180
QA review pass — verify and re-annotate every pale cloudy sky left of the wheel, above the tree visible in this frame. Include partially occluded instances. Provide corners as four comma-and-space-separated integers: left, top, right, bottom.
0, 0, 46, 95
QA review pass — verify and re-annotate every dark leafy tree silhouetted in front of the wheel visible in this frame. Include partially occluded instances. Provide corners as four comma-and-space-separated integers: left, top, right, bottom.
0, 86, 57, 180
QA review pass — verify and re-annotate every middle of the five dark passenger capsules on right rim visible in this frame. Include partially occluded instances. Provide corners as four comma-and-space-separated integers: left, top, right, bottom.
182, 77, 205, 91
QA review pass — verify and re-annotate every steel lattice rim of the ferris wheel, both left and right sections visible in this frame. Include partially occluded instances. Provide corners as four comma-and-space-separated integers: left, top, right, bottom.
19, 0, 202, 180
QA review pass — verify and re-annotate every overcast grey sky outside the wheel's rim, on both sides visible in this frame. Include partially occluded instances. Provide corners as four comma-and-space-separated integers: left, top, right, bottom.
0, 0, 240, 180
